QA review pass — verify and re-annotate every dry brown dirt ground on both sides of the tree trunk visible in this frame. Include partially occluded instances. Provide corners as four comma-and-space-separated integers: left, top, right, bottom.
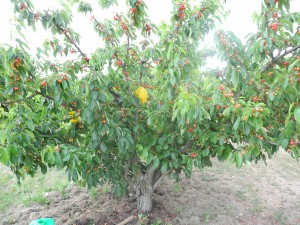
0, 149, 300, 225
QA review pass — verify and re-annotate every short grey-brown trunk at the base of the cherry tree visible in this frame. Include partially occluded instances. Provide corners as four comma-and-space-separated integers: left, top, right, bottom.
135, 173, 153, 215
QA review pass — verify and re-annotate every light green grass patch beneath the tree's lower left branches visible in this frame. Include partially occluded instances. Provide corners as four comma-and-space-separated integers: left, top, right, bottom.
0, 165, 69, 212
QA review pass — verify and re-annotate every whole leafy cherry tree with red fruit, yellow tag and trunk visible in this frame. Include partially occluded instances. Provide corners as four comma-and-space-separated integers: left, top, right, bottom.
0, 0, 300, 213
